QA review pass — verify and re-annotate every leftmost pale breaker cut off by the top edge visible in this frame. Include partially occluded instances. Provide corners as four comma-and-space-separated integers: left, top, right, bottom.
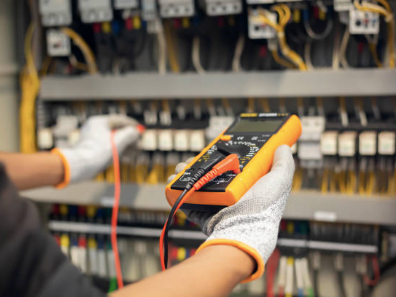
39, 0, 72, 27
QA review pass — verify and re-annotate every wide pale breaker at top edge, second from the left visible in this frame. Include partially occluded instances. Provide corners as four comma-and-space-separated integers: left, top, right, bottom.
78, 0, 113, 23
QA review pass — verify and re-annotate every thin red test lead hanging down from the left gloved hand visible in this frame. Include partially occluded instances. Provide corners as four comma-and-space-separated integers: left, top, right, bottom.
110, 131, 124, 289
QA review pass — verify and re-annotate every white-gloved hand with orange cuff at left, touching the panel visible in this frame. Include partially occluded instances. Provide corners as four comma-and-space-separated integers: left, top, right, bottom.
52, 115, 140, 188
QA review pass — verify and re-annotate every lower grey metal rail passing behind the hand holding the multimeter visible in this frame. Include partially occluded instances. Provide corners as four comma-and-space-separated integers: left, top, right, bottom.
21, 182, 396, 225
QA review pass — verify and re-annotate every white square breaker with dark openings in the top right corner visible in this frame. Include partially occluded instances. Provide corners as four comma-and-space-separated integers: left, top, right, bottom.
349, 9, 380, 34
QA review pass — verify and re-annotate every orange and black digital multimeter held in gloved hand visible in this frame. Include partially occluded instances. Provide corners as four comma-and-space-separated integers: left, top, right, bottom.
165, 113, 302, 210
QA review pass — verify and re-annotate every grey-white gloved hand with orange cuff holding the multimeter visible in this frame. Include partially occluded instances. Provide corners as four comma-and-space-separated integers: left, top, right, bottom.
169, 145, 294, 282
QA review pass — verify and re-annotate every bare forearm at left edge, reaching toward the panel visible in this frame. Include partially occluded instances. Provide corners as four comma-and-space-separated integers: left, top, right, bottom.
0, 152, 64, 190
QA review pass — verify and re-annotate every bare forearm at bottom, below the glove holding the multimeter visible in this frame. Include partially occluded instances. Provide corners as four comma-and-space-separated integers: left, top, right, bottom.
112, 245, 255, 297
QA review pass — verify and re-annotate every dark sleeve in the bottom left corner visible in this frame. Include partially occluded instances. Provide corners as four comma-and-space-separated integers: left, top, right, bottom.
0, 163, 105, 297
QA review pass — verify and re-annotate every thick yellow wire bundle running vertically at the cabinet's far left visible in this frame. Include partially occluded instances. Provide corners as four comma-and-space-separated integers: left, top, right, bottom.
19, 23, 40, 153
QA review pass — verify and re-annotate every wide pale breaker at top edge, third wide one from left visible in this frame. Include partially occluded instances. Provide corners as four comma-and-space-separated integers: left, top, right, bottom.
159, 0, 195, 18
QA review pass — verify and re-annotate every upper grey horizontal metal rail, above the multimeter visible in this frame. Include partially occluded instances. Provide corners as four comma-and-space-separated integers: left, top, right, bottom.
40, 69, 396, 101
